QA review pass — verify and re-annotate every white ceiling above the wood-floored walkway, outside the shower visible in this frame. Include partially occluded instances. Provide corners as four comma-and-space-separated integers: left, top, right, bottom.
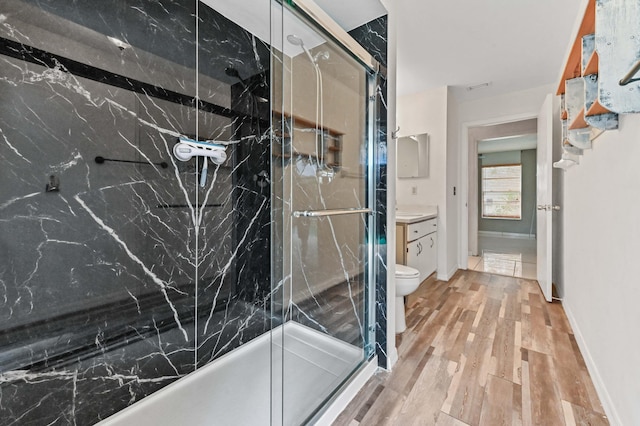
396, 0, 582, 100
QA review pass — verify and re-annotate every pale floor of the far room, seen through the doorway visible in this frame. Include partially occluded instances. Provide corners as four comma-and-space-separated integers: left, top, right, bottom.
468, 236, 537, 279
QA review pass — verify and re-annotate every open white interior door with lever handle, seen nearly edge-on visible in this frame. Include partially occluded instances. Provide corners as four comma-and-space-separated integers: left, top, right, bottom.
536, 95, 554, 302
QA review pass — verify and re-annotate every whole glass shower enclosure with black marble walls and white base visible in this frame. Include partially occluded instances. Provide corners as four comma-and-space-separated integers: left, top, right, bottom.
0, 0, 385, 426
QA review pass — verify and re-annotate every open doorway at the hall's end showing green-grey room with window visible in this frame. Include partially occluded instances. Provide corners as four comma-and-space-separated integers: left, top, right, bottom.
467, 118, 537, 279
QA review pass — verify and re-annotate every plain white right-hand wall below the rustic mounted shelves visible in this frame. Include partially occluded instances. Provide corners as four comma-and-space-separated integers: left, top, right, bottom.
563, 114, 640, 425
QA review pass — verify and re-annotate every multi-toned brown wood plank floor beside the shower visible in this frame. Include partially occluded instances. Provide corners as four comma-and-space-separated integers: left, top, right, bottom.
334, 271, 609, 426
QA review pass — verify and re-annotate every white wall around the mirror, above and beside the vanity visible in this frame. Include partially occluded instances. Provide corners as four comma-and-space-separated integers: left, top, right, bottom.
396, 87, 450, 280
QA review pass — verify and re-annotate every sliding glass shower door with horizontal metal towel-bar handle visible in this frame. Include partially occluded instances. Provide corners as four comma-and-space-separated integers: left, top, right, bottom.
272, 1, 375, 425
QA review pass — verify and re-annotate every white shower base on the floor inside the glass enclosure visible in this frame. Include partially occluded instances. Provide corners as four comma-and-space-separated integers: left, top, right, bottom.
99, 321, 375, 426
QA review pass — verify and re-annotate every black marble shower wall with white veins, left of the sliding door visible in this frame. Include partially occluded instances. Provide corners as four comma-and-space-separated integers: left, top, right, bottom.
0, 0, 271, 425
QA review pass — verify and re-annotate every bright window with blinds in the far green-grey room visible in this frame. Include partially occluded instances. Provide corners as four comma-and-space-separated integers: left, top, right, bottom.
482, 164, 522, 219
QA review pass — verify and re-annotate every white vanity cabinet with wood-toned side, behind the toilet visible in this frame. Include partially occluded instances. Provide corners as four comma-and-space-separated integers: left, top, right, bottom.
396, 218, 438, 281
